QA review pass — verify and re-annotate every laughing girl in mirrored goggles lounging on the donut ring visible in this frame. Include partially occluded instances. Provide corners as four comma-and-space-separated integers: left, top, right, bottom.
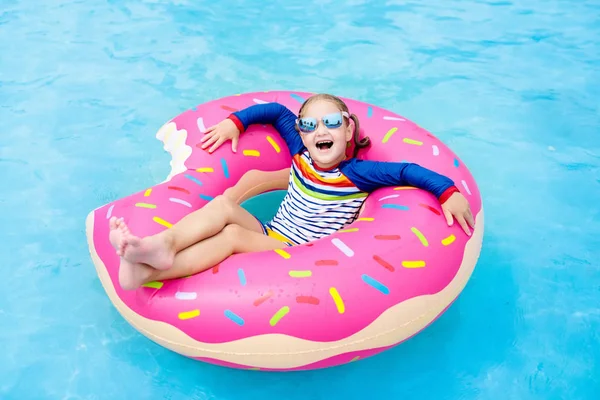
109, 94, 474, 290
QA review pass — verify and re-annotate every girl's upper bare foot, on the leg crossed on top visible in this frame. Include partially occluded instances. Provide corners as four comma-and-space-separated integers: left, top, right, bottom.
121, 222, 175, 271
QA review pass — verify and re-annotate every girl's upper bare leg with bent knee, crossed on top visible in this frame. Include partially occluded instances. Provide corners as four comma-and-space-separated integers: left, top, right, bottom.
115, 196, 263, 270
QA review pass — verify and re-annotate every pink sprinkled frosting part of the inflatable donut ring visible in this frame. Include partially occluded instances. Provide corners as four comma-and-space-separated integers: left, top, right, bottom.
93, 92, 481, 366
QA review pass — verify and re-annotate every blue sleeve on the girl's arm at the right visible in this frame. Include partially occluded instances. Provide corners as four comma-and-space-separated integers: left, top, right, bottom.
341, 158, 454, 198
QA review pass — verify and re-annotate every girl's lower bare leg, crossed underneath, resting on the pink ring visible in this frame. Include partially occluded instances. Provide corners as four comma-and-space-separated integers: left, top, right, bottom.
119, 224, 287, 290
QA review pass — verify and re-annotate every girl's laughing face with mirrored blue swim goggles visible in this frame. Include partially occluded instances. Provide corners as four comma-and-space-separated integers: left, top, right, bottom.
300, 100, 352, 169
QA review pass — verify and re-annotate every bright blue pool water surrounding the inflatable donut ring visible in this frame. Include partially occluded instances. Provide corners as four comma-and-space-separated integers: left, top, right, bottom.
0, 0, 600, 400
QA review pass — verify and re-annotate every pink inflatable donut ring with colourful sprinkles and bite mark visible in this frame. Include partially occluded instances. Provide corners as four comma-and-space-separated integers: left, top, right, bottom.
86, 91, 484, 371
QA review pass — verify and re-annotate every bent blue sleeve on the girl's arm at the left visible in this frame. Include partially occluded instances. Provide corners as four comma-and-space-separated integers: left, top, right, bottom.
233, 103, 304, 156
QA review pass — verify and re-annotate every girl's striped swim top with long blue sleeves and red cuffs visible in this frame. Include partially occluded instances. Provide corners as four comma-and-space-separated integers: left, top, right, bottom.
229, 103, 458, 245
